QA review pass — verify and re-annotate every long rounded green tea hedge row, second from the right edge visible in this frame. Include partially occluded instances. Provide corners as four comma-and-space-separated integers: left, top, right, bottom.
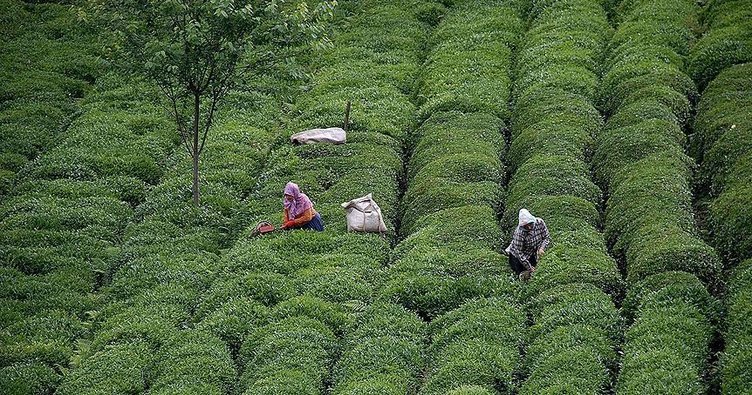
594, 0, 721, 318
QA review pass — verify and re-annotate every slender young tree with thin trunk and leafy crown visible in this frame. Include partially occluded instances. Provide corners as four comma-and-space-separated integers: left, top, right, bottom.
91, 0, 337, 206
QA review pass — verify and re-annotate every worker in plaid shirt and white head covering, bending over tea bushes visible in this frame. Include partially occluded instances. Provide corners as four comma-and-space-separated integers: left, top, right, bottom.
504, 208, 551, 275
